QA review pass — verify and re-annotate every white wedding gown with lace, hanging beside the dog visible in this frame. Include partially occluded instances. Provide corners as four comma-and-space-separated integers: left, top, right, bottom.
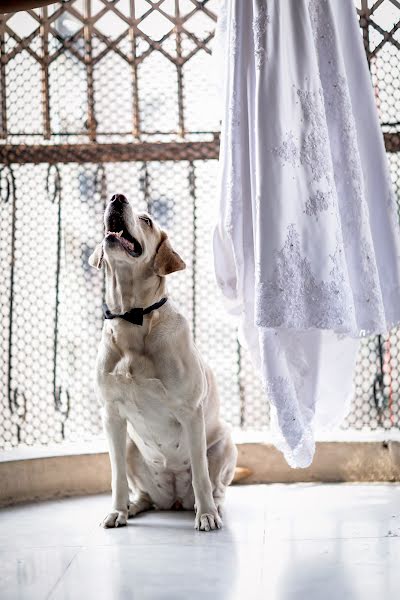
214, 0, 400, 467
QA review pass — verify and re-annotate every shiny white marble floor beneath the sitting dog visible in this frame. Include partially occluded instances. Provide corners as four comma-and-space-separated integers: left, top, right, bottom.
0, 484, 400, 600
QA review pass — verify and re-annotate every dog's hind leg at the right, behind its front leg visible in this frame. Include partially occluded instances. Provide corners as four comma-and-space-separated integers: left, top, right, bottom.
207, 434, 237, 513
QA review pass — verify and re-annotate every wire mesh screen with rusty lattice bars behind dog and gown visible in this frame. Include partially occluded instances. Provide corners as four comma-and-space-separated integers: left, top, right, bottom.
0, 0, 400, 448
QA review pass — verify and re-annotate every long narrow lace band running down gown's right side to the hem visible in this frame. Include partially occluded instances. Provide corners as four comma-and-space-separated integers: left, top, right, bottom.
309, 0, 385, 335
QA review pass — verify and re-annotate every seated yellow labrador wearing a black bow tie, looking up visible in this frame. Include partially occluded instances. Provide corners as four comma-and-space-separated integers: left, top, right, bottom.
89, 195, 237, 531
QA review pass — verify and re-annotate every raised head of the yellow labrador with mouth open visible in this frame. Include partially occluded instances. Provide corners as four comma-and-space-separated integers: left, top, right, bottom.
89, 194, 186, 277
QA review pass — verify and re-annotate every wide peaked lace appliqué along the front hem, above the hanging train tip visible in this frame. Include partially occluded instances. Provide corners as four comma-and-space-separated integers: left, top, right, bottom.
256, 224, 352, 332
